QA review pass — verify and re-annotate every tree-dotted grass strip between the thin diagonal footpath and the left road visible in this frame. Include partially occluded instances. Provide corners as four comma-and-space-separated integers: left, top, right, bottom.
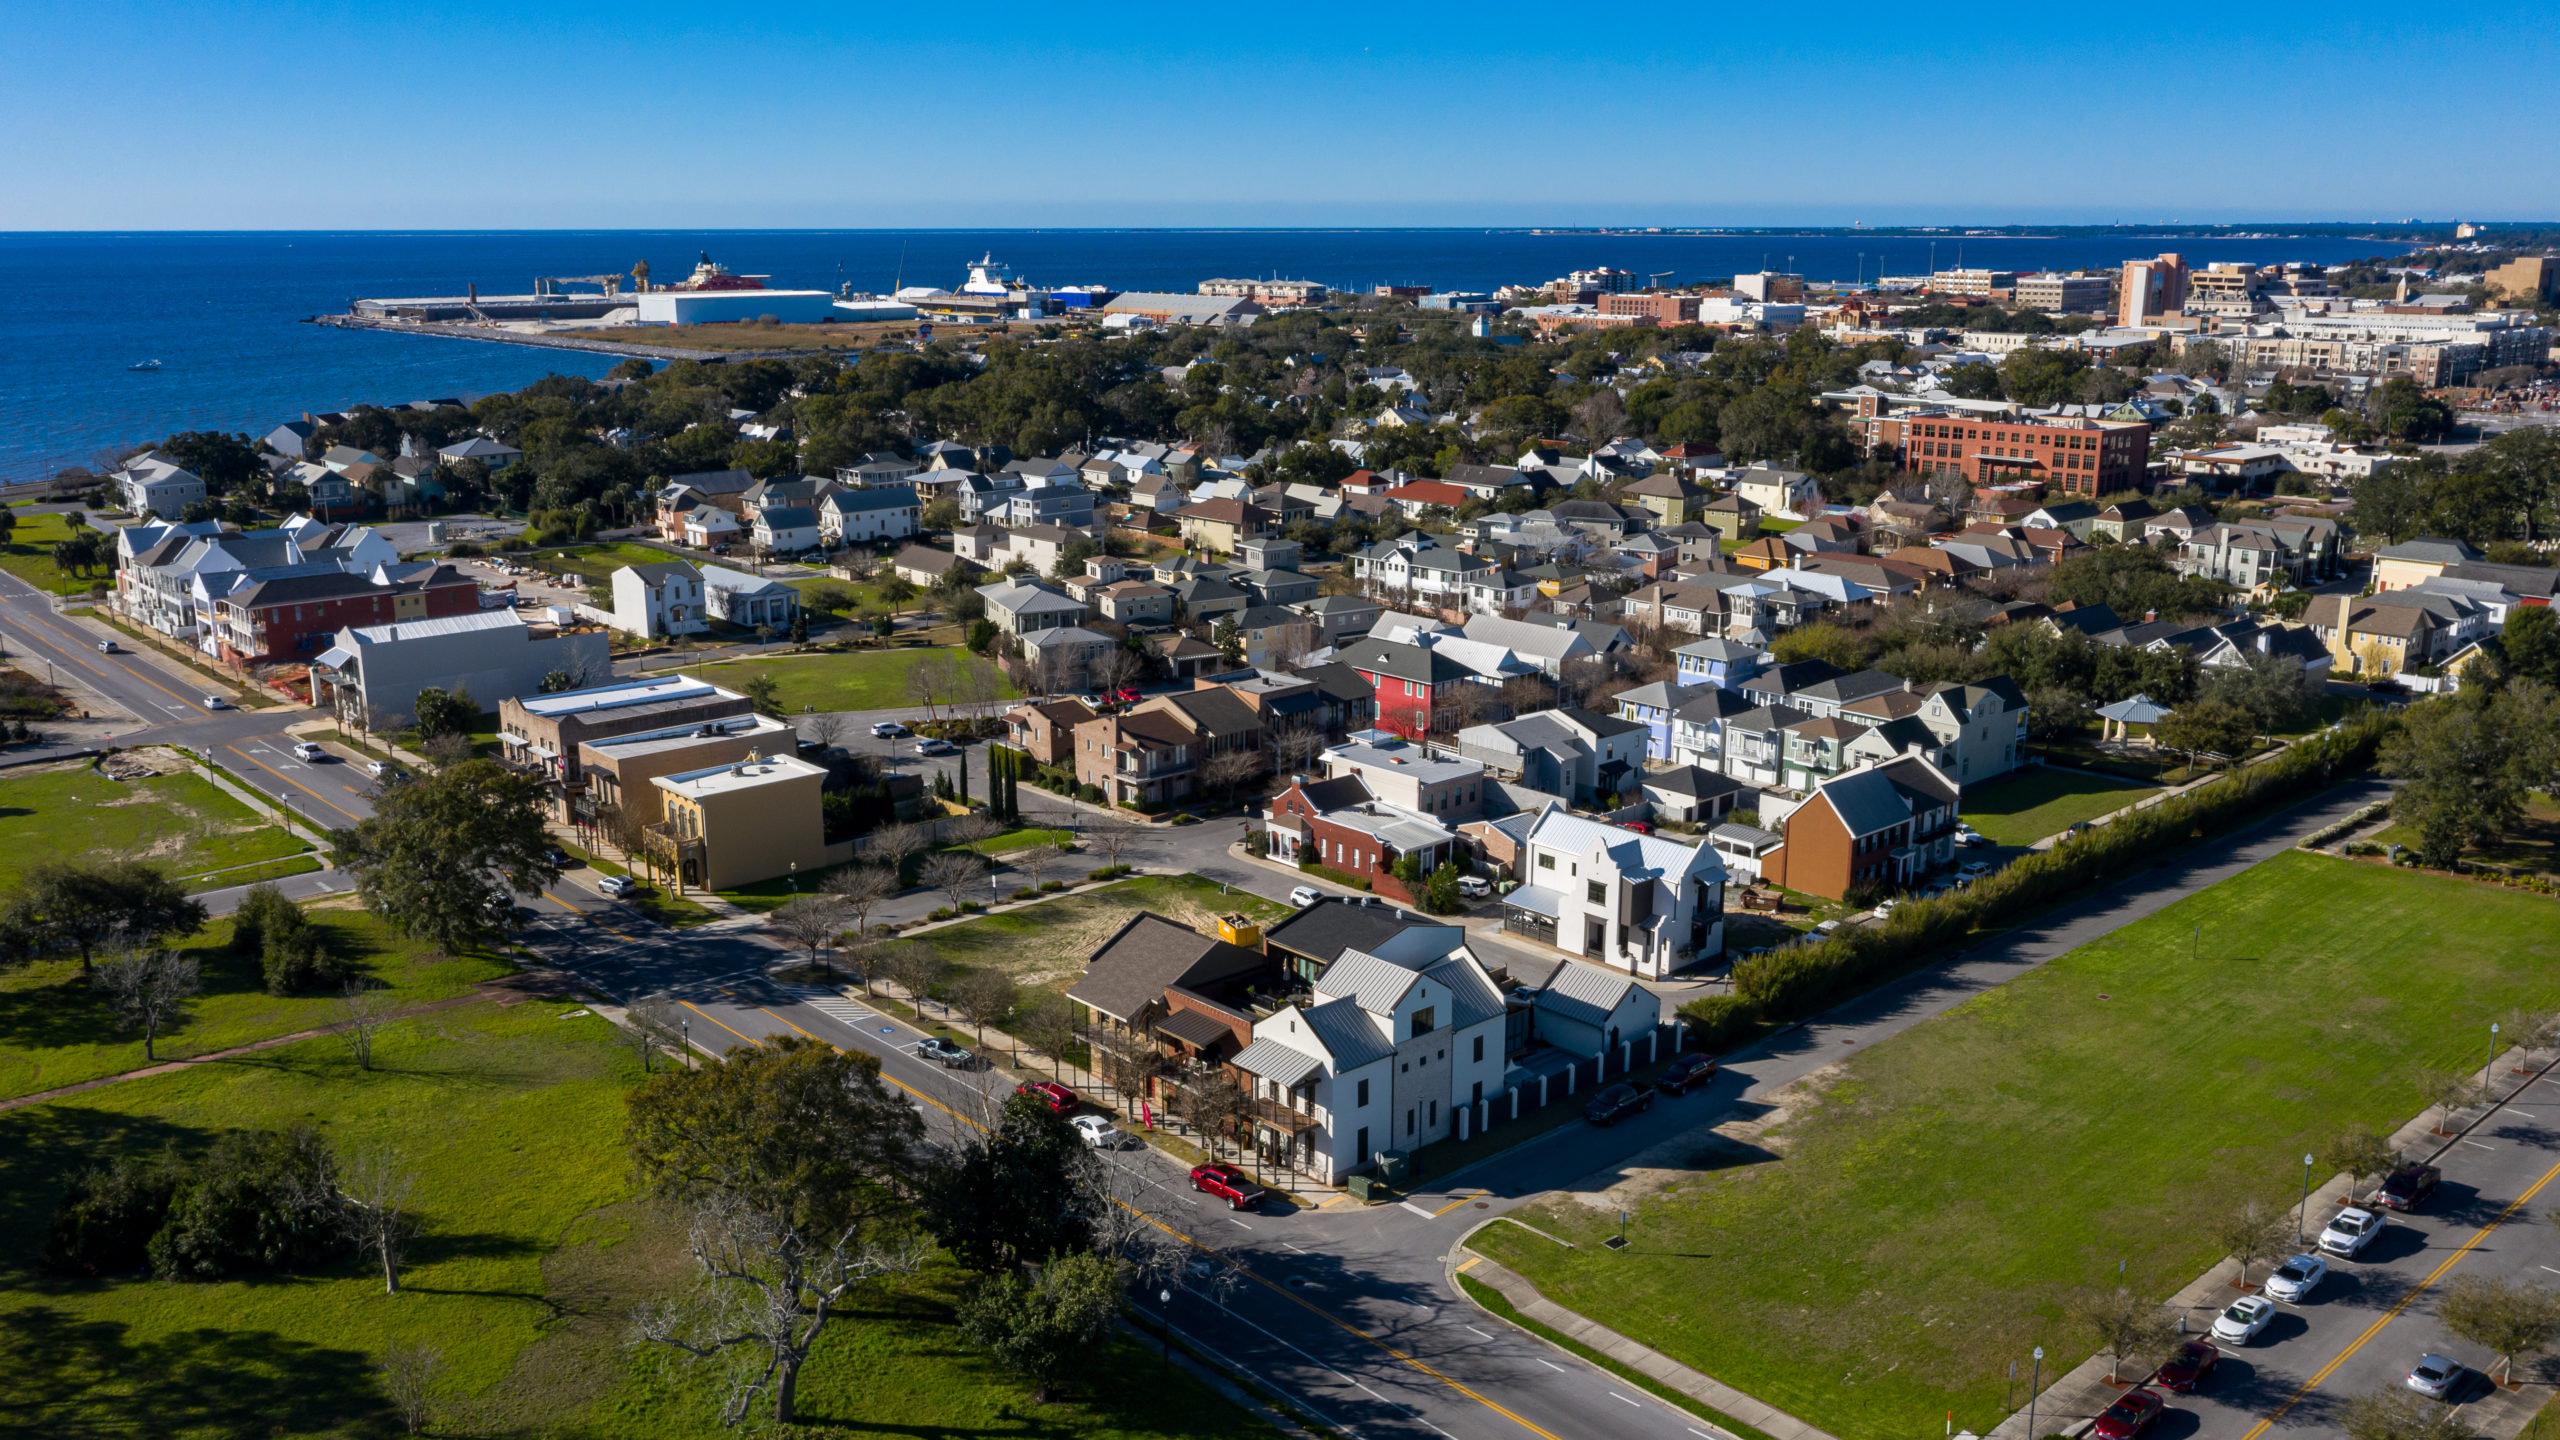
0, 907, 515, 1097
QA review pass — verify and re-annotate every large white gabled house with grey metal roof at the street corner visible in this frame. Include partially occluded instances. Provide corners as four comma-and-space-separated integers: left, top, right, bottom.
1234, 945, 1508, 1181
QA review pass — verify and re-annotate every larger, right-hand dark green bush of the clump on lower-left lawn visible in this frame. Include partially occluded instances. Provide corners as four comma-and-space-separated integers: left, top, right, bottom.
146, 1127, 348, 1281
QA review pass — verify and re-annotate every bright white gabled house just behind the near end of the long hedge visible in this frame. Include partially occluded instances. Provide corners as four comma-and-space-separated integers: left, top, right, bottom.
1503, 805, 1725, 979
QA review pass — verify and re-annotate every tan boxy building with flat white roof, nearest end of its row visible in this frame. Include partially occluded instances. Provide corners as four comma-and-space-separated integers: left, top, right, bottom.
650, 756, 827, 889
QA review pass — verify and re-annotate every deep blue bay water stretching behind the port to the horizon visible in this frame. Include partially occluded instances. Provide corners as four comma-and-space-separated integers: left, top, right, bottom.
0, 231, 2399, 479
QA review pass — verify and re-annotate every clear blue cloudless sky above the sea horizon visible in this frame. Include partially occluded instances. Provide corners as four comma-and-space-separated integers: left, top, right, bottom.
0, 0, 2560, 231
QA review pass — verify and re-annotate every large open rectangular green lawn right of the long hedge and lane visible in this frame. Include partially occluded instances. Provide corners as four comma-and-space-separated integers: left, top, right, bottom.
1477, 851, 2560, 1435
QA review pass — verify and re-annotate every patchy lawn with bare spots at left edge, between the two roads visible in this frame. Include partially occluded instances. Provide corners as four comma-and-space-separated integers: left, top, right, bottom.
0, 764, 310, 887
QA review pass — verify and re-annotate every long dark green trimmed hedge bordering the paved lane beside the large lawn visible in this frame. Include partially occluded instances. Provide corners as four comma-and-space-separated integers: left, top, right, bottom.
1679, 712, 2396, 1048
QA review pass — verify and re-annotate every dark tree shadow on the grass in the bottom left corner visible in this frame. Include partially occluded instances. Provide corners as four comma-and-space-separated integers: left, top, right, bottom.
0, 1304, 392, 1435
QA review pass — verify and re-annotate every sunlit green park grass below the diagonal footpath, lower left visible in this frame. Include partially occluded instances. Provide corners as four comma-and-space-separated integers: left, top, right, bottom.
0, 983, 1280, 1440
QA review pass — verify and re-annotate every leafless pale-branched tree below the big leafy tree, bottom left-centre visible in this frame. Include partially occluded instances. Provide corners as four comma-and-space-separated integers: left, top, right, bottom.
632, 1197, 929, 1425
